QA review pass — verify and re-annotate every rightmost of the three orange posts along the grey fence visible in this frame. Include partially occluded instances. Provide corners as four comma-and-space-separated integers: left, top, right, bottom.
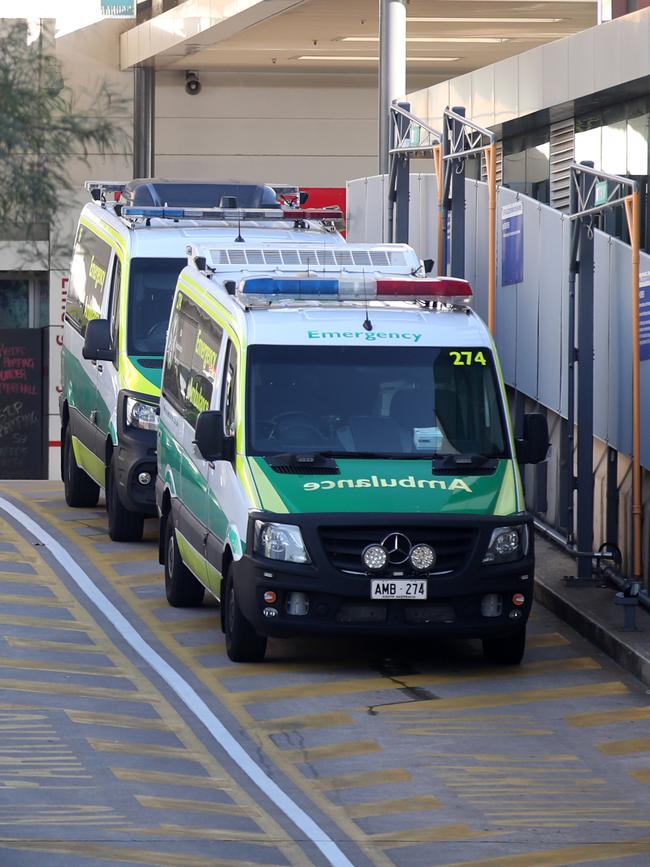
625, 190, 643, 581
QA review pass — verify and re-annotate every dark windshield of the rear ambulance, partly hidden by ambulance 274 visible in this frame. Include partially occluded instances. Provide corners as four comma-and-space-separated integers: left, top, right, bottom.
127, 258, 187, 356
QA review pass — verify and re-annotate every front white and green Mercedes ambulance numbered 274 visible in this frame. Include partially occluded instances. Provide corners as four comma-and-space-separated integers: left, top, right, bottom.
156, 210, 548, 663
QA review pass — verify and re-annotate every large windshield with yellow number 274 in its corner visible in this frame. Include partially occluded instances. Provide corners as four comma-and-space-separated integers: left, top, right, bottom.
247, 345, 508, 458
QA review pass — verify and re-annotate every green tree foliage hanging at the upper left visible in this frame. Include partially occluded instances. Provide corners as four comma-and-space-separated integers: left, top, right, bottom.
0, 20, 130, 238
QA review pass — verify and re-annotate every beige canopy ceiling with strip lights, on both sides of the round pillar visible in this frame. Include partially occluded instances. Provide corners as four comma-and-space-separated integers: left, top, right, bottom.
121, 0, 597, 84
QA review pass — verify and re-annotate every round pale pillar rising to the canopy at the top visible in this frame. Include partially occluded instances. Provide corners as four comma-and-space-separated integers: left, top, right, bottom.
379, 0, 406, 174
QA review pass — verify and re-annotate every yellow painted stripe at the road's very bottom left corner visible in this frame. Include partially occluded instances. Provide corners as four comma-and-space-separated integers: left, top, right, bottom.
0, 848, 284, 867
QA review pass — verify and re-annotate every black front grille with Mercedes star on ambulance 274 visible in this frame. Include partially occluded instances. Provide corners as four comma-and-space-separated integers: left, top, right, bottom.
319, 525, 477, 573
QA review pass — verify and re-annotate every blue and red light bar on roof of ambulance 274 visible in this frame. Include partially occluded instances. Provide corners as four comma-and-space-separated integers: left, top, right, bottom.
239, 275, 472, 306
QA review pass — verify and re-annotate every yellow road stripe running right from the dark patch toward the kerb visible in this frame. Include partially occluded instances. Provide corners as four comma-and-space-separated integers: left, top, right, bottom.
375, 681, 629, 716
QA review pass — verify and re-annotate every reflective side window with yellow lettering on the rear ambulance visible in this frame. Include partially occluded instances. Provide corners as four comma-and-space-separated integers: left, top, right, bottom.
66, 226, 112, 334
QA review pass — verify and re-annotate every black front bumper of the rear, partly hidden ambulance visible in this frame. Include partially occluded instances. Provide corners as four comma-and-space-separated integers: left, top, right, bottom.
113, 391, 157, 517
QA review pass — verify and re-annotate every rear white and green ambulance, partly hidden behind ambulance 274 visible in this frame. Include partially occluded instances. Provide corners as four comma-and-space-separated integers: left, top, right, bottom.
60, 179, 279, 541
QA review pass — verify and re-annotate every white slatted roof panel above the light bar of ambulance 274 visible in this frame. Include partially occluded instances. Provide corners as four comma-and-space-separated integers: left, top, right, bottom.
210, 247, 406, 268
